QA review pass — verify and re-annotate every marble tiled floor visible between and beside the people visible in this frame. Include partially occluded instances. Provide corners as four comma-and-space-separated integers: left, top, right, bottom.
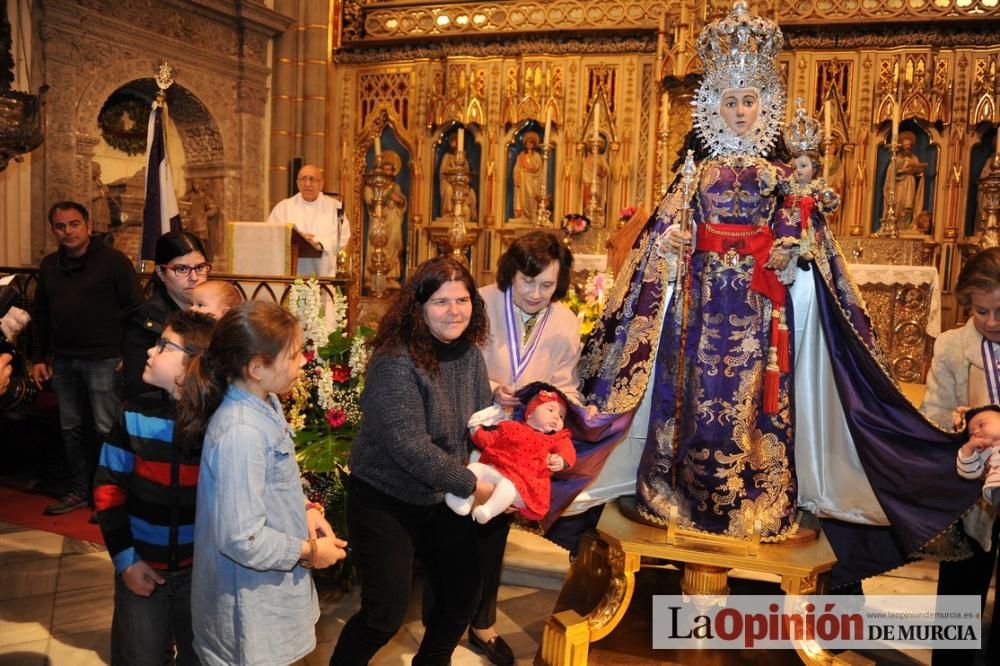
0, 523, 992, 666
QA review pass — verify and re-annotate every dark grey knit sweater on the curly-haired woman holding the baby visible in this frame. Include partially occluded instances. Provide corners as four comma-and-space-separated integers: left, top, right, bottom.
350, 346, 492, 505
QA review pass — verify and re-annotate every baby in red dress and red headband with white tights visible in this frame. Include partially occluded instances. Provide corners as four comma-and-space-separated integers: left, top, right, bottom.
444, 384, 576, 523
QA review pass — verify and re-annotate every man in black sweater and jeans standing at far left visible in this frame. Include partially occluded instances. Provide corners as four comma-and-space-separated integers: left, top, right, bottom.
31, 201, 142, 515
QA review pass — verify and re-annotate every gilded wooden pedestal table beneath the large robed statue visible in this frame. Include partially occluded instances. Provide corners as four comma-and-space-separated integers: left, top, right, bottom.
535, 504, 846, 666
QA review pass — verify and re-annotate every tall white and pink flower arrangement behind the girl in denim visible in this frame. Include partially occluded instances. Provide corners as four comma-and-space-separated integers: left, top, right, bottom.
281, 278, 374, 556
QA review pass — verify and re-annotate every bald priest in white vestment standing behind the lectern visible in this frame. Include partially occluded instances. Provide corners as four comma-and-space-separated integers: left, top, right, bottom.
267, 164, 351, 277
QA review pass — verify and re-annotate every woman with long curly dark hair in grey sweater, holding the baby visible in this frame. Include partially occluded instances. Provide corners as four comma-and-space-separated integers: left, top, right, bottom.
330, 257, 493, 665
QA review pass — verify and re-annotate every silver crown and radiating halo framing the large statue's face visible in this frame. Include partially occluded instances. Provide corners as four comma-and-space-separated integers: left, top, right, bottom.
694, 0, 785, 156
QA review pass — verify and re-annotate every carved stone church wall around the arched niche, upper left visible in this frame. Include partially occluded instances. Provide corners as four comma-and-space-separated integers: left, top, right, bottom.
14, 0, 288, 261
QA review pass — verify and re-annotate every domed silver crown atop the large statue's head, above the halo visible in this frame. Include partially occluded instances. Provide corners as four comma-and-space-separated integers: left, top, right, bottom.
696, 0, 785, 89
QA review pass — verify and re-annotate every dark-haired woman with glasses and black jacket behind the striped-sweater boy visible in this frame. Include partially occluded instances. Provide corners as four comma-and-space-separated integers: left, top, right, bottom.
122, 231, 212, 402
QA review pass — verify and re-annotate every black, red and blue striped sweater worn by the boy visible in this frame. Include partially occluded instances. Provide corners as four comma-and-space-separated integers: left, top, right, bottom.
94, 397, 199, 572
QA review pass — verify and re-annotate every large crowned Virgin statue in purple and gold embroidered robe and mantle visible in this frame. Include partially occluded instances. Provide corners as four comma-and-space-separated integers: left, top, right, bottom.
553, 2, 978, 585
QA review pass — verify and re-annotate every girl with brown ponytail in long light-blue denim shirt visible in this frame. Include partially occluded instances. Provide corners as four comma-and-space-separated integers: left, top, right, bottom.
178, 301, 347, 666
